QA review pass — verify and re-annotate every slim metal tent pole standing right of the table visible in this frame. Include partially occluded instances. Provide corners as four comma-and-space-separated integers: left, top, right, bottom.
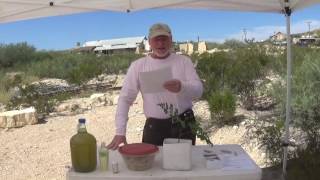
282, 4, 292, 176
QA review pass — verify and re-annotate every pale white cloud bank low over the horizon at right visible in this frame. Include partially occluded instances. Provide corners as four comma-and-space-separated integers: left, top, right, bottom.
206, 19, 320, 43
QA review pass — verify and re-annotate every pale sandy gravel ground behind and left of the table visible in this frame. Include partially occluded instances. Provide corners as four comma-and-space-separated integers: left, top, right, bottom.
0, 95, 263, 180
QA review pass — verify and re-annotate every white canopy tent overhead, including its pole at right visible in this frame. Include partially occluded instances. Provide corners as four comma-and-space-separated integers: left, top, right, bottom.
0, 0, 320, 174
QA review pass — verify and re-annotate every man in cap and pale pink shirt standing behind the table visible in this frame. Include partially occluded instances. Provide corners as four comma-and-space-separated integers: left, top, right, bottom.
108, 23, 203, 150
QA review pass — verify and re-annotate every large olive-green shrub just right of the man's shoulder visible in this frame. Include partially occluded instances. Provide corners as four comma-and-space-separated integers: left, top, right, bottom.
197, 45, 273, 99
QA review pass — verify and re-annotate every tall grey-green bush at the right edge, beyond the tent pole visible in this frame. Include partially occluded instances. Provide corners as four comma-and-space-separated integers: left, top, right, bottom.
292, 51, 320, 135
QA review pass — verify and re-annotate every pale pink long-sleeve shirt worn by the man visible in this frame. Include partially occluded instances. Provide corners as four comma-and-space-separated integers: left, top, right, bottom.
116, 53, 203, 135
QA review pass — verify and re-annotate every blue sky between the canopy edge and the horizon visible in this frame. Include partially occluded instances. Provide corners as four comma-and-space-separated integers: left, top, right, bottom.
0, 5, 320, 50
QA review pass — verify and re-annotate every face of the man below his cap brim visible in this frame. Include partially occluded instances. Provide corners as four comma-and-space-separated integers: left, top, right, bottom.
149, 36, 172, 58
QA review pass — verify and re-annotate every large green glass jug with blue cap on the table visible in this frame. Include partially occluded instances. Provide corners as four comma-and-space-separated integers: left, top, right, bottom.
70, 119, 97, 172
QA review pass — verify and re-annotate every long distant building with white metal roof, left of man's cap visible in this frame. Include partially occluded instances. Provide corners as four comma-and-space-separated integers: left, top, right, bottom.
73, 36, 150, 54
